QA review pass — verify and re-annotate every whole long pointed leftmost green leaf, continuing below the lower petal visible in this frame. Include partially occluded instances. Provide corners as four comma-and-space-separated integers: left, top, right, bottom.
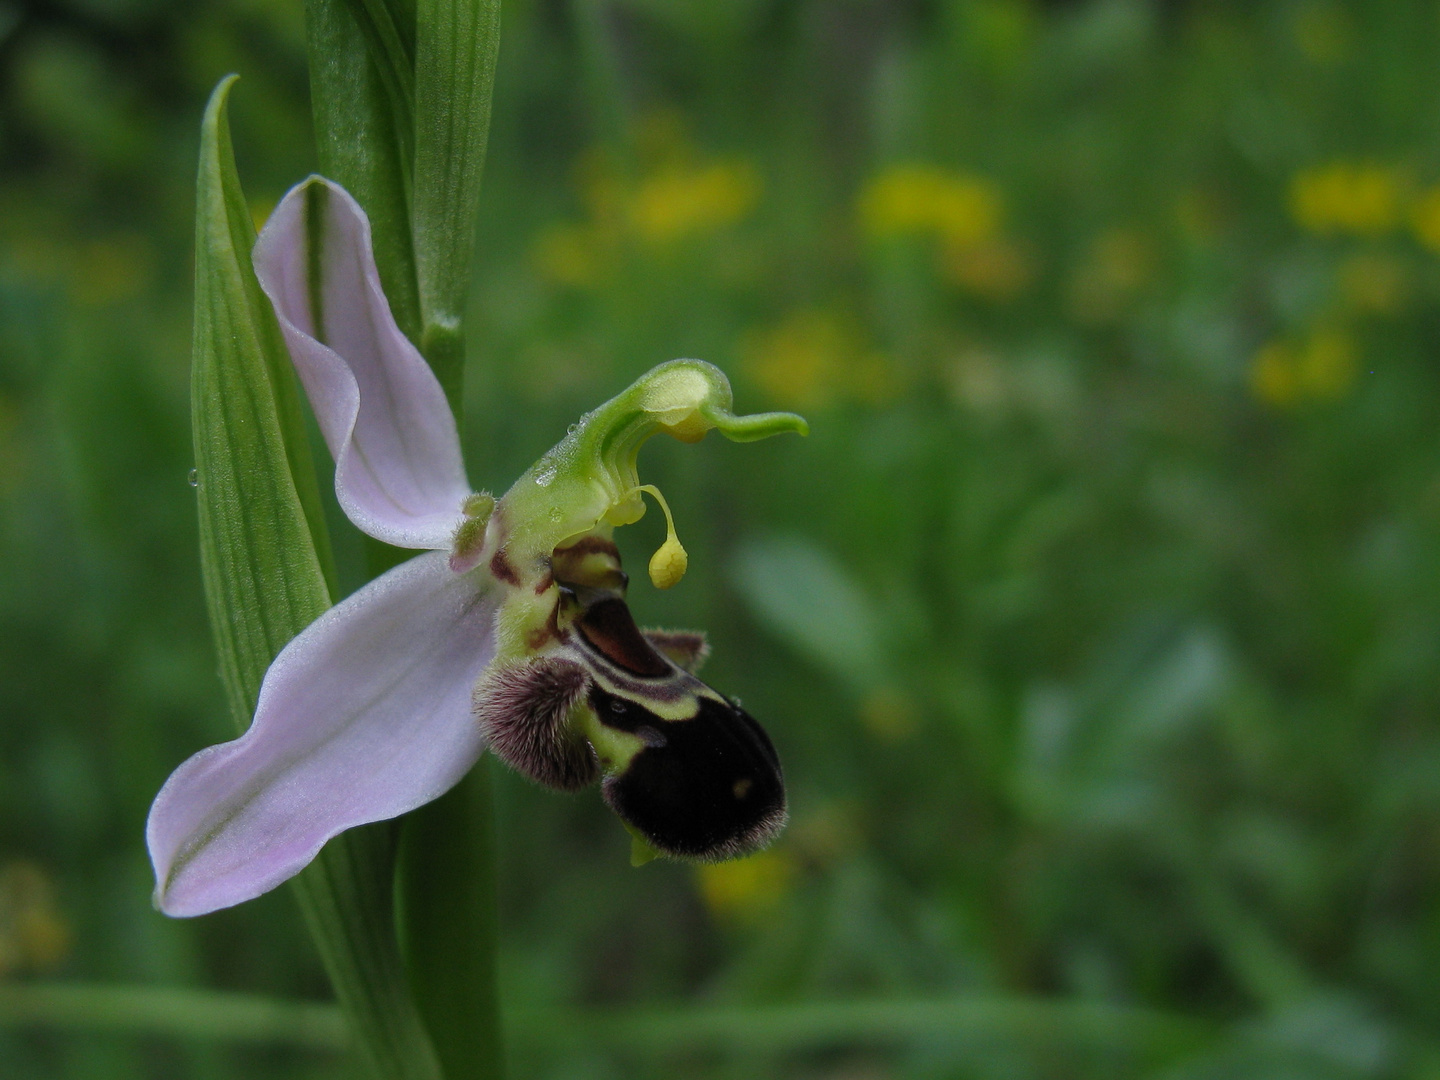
192, 79, 439, 1080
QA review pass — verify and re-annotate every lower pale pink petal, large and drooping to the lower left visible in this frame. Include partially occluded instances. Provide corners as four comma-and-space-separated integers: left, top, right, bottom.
145, 552, 495, 916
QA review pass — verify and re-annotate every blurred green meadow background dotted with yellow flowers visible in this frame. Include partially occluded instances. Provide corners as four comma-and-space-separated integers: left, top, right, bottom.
0, 0, 1440, 1080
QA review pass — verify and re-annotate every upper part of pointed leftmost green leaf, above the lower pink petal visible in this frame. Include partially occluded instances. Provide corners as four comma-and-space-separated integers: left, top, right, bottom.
192, 76, 330, 729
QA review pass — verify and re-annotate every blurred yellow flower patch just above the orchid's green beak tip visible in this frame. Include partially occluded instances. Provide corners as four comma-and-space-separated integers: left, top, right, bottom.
740, 308, 901, 408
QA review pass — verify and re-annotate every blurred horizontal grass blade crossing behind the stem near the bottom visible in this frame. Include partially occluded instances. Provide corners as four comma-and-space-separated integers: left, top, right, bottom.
0, 984, 1209, 1080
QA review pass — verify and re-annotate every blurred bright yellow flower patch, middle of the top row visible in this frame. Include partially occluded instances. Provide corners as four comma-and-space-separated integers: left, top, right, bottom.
858, 163, 1004, 246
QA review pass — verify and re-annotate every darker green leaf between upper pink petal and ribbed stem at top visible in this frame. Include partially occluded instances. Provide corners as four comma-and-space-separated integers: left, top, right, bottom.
305, 0, 420, 341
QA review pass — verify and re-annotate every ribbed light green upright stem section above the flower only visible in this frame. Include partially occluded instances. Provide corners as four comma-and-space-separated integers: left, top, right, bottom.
412, 0, 500, 410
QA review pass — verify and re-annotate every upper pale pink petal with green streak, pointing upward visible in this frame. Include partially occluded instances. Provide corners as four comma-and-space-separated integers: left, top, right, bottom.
255, 177, 469, 547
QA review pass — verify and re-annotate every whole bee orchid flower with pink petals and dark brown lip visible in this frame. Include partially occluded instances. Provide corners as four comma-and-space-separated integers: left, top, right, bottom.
147, 177, 805, 916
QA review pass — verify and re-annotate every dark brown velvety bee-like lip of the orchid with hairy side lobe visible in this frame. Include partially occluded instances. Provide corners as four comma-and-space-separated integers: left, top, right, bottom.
475, 537, 785, 861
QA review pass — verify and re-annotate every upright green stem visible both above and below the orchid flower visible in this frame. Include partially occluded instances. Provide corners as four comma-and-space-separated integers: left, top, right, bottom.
406, 0, 504, 1080
